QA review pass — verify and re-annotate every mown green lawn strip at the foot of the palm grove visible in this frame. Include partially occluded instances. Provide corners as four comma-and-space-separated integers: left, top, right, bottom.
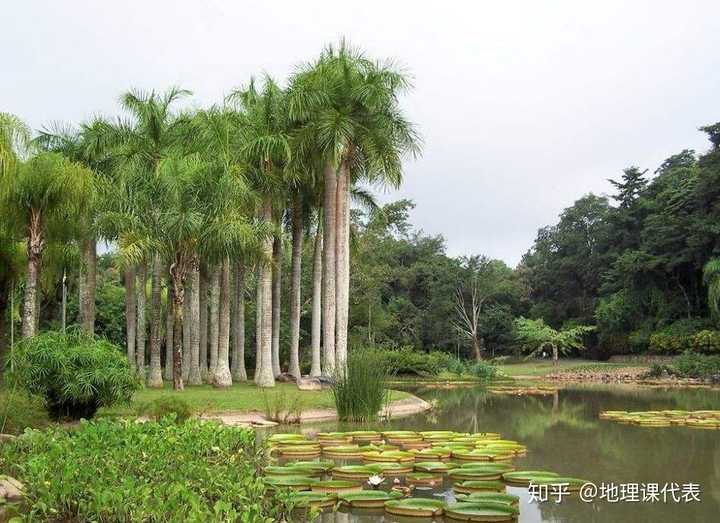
100, 382, 409, 416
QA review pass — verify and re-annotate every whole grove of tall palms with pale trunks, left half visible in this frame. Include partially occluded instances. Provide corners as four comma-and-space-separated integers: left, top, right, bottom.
0, 42, 419, 390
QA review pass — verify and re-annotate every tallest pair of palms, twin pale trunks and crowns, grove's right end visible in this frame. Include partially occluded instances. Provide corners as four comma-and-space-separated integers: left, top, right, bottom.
289, 42, 419, 372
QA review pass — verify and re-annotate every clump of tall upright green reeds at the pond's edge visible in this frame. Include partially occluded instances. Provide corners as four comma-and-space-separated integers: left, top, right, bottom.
331, 349, 390, 421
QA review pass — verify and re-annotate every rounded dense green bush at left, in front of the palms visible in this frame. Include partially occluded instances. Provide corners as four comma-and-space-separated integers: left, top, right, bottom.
9, 330, 141, 419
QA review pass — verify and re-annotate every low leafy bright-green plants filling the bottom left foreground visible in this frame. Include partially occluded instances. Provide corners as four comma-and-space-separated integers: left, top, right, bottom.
0, 419, 288, 522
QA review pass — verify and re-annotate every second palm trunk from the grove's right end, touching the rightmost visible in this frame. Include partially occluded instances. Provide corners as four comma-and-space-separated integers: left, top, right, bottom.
322, 163, 337, 375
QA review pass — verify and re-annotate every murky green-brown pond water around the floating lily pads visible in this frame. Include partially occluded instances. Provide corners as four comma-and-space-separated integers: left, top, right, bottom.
272, 385, 720, 523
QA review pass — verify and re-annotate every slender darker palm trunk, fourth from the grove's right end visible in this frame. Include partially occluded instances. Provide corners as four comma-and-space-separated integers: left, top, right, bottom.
288, 195, 303, 380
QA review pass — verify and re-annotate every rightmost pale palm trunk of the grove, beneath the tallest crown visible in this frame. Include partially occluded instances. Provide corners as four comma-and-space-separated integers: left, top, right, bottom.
335, 163, 350, 372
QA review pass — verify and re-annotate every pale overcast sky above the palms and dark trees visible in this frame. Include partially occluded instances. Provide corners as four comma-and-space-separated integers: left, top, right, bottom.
5, 0, 720, 265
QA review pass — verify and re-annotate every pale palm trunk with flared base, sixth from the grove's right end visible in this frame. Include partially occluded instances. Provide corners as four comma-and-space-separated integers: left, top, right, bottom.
255, 199, 275, 387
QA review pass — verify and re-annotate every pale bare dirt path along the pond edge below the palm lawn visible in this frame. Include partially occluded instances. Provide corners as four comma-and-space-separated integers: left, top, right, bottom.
202, 396, 432, 427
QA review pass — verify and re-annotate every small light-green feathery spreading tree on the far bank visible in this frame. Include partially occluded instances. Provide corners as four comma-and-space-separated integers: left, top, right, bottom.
515, 318, 595, 364
